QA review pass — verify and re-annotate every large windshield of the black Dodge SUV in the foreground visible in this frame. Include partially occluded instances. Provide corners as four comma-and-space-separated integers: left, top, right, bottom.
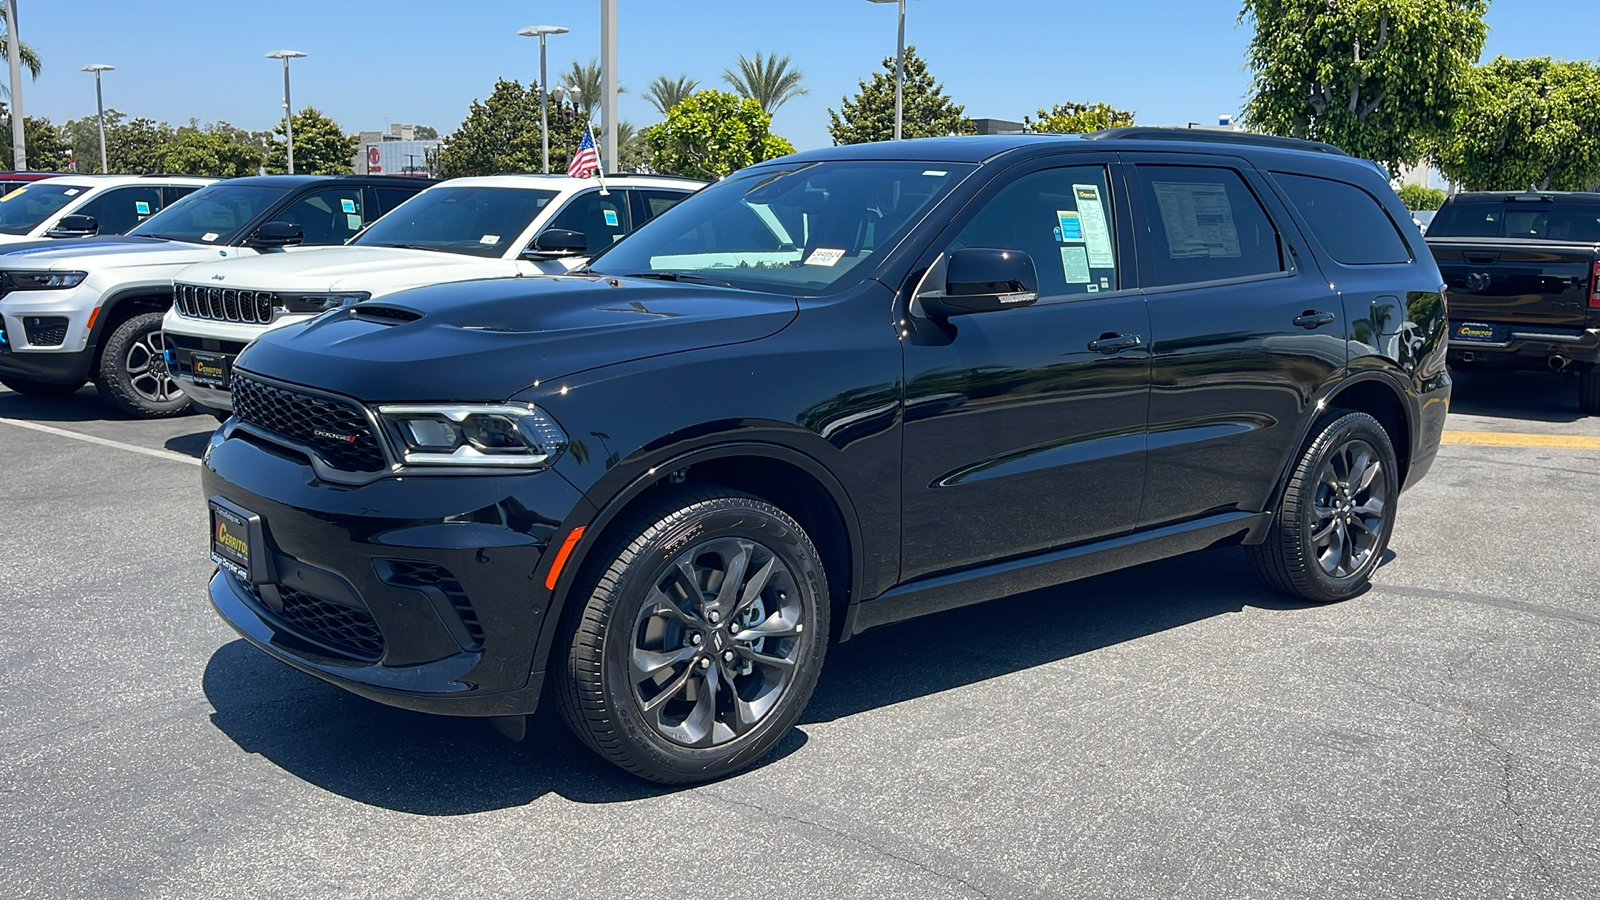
590, 160, 976, 295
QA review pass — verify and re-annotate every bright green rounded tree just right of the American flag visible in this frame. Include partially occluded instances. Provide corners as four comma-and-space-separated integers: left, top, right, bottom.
643, 90, 794, 181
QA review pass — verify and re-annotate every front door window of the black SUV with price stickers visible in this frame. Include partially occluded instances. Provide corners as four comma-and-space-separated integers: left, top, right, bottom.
949, 165, 1120, 296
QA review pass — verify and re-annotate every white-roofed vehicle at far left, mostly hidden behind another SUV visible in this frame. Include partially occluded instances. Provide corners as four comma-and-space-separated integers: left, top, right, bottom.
0, 175, 216, 243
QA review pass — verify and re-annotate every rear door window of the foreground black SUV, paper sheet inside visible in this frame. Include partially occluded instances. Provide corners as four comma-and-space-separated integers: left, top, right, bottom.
1139, 165, 1283, 287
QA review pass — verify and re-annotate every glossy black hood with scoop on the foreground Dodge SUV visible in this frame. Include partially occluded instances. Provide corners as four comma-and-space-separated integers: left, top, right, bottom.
238, 275, 798, 402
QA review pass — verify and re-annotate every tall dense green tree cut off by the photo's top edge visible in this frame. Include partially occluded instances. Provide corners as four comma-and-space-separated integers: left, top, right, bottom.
1238, 0, 1488, 175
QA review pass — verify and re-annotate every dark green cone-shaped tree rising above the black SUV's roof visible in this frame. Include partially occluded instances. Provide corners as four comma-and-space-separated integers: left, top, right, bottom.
827, 46, 974, 144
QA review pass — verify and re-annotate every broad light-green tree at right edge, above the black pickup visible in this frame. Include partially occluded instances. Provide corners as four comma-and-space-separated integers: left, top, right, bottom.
1434, 56, 1600, 191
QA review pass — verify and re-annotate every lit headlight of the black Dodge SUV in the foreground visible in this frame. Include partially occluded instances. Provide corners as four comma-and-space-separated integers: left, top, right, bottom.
378, 404, 566, 469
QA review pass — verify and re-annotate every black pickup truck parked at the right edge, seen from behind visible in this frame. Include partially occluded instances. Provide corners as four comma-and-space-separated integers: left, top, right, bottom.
1427, 191, 1600, 415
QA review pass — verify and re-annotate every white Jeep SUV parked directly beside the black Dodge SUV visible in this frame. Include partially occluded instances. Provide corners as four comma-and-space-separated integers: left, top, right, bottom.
162, 175, 704, 418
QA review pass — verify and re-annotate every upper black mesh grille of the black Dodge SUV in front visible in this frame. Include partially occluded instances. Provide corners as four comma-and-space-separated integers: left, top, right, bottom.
230, 372, 387, 472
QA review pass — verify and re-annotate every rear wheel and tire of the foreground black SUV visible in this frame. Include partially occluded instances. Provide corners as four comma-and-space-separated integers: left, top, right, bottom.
1245, 410, 1400, 604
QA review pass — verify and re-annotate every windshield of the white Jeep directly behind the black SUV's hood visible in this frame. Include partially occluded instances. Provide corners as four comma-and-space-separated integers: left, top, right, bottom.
352, 187, 555, 258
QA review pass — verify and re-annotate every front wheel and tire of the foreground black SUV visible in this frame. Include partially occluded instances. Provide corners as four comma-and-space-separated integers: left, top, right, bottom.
557, 488, 829, 785
